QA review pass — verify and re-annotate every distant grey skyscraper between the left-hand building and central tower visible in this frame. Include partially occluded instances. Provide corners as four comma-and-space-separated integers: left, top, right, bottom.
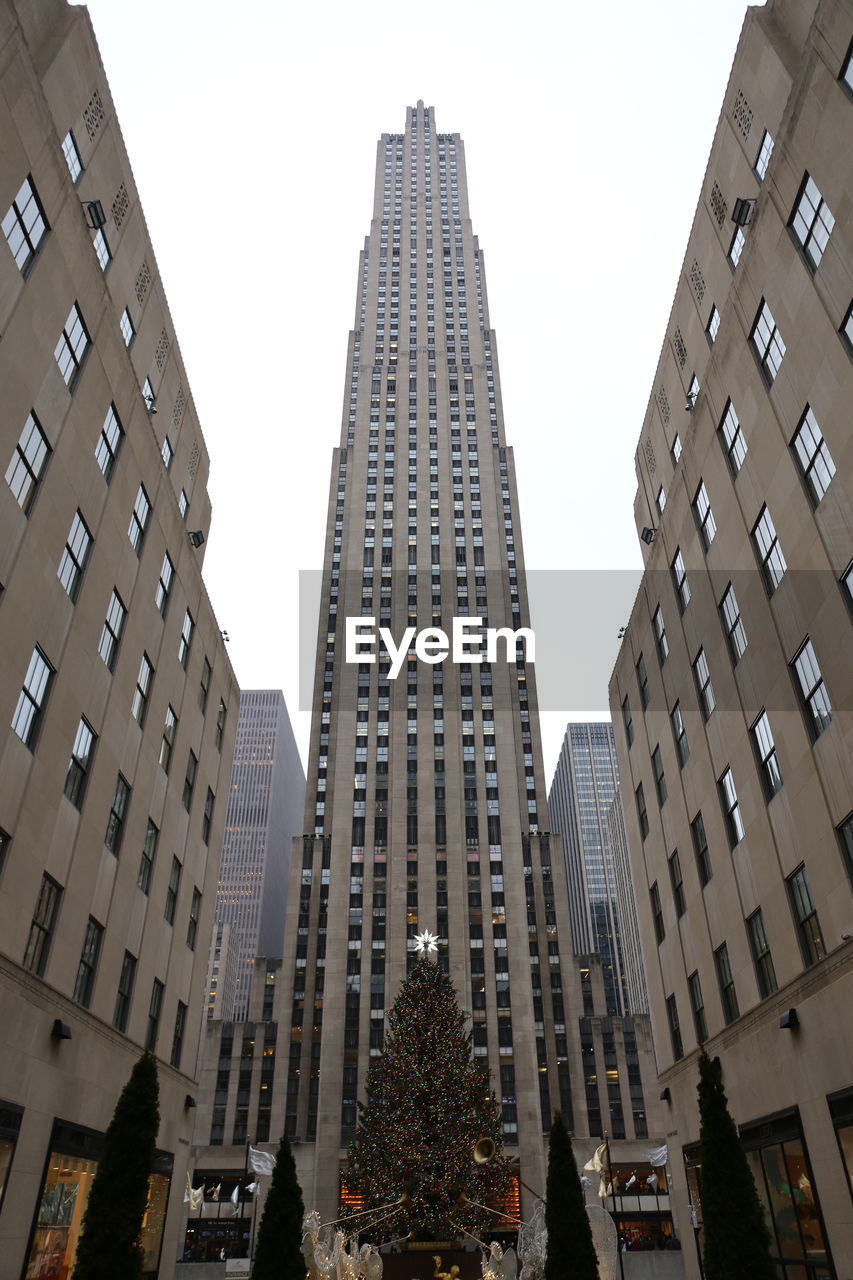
209, 689, 305, 1019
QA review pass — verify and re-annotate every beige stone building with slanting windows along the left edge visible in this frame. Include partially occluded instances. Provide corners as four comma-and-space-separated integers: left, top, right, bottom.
0, 0, 238, 1276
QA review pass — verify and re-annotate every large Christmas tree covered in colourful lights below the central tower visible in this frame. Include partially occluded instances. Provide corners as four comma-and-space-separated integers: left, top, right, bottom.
345, 956, 512, 1240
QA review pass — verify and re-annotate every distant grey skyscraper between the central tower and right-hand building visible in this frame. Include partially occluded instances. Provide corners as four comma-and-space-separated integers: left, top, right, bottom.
548, 722, 644, 1014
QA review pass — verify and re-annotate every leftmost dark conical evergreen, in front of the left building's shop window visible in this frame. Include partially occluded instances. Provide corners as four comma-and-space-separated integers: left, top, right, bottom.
73, 1053, 160, 1280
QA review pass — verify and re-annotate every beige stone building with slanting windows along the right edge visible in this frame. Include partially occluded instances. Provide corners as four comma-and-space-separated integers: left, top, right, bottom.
610, 0, 853, 1280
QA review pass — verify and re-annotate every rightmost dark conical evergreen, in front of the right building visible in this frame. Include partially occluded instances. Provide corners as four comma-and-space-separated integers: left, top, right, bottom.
699, 1052, 776, 1280
